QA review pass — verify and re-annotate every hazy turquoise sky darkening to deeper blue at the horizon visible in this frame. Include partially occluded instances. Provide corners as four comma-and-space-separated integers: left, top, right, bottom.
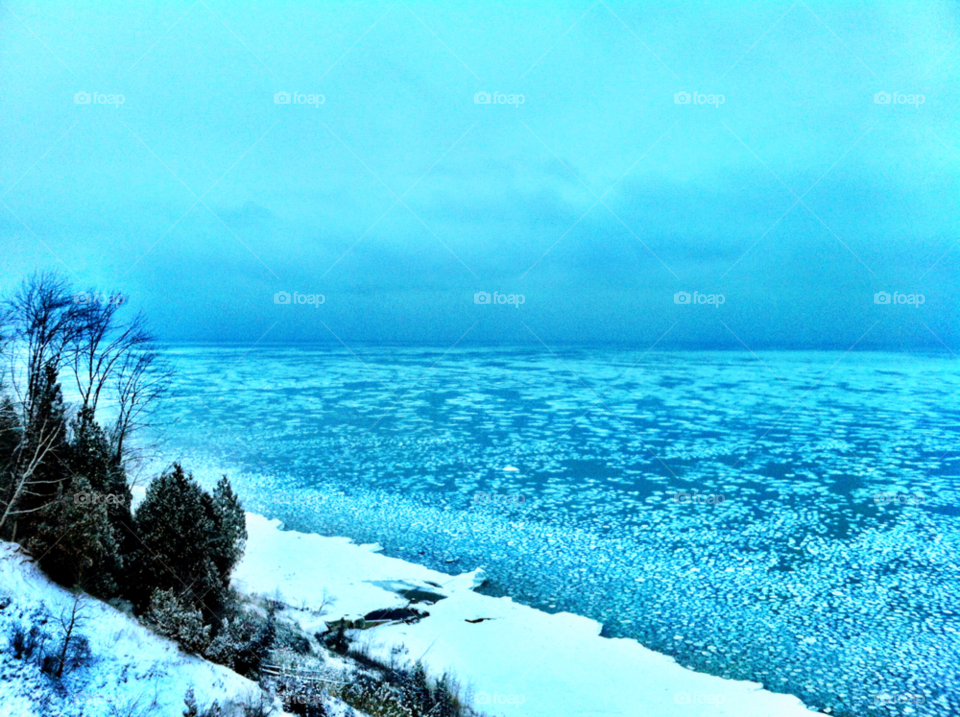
0, 0, 960, 354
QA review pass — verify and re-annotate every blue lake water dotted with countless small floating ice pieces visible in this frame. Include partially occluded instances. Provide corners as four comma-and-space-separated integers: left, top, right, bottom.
148, 347, 960, 717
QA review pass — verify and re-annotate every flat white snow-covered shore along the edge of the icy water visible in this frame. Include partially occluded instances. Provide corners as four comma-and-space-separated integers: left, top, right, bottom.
234, 513, 814, 717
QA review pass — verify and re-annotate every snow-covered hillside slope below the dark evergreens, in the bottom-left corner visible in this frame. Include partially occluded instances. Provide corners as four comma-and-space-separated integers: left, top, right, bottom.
0, 542, 270, 717
